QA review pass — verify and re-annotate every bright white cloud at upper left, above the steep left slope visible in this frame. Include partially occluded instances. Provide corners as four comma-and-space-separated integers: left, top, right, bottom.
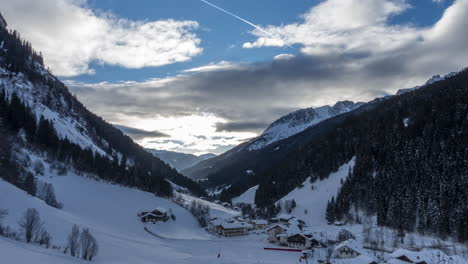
0, 0, 202, 76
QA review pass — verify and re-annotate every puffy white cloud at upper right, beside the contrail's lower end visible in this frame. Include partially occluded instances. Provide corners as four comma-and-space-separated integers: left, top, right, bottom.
243, 0, 418, 54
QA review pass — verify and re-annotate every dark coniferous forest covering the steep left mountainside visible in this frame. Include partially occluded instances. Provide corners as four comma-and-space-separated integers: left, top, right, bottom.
0, 28, 205, 199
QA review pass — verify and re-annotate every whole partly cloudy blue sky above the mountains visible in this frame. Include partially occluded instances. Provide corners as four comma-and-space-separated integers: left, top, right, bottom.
0, 0, 468, 154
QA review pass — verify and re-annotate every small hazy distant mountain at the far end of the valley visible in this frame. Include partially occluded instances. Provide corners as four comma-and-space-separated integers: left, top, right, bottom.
147, 149, 216, 171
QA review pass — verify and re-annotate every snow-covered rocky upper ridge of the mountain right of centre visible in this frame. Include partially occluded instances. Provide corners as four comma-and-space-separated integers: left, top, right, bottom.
248, 101, 364, 150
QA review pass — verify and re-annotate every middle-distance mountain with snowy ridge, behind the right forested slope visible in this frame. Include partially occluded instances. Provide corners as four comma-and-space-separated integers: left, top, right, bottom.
182, 101, 363, 193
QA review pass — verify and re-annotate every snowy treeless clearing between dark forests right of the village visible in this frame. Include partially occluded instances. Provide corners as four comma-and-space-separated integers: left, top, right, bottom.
279, 159, 354, 226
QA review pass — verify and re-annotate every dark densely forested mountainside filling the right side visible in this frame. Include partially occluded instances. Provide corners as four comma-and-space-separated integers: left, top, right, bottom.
256, 69, 468, 241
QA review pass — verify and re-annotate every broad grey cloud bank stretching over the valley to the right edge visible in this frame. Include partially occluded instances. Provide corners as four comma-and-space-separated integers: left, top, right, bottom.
47, 0, 468, 153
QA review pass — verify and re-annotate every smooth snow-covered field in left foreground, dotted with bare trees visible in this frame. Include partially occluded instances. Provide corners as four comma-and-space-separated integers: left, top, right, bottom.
0, 168, 306, 264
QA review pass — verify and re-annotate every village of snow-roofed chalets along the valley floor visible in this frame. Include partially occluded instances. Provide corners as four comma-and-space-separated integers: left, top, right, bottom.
138, 201, 465, 264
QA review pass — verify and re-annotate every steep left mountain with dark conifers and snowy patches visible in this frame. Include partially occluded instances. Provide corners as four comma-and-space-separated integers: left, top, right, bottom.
0, 24, 205, 196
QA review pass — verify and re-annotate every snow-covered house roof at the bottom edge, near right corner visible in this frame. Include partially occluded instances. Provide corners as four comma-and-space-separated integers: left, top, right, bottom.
387, 248, 456, 264
